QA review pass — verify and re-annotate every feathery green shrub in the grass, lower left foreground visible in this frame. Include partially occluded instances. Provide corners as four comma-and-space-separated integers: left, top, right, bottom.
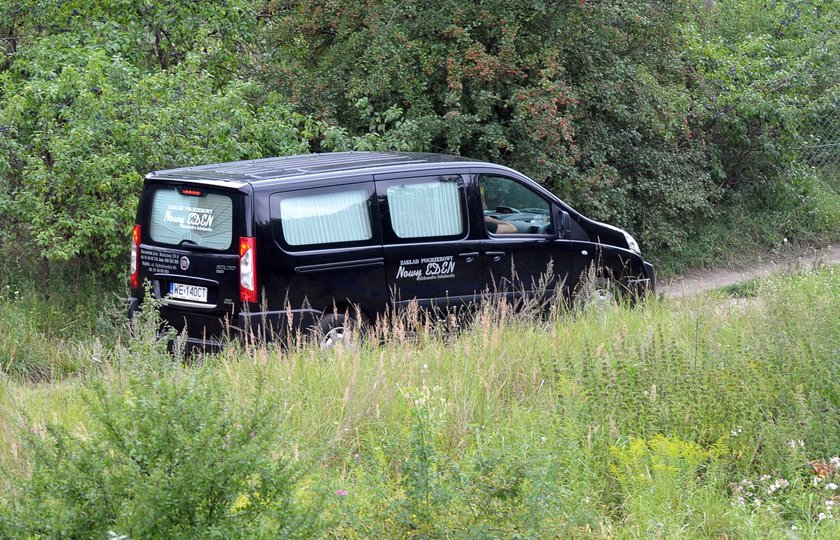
2, 371, 316, 538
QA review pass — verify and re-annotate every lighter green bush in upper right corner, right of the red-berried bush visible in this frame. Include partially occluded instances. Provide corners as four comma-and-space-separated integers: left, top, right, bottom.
683, 0, 840, 192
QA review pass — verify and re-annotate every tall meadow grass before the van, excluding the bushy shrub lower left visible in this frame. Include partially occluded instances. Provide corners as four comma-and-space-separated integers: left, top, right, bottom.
0, 267, 840, 538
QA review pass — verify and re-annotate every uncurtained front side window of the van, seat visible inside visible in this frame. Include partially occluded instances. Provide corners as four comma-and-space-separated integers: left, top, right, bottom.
478, 174, 554, 234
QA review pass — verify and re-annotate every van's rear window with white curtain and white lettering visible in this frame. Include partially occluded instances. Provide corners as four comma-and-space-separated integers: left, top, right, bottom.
149, 188, 233, 250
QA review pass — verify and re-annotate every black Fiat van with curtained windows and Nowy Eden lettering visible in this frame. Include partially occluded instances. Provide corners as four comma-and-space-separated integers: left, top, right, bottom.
129, 152, 654, 347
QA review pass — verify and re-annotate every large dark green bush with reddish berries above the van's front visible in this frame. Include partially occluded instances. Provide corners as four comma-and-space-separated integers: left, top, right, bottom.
264, 0, 716, 253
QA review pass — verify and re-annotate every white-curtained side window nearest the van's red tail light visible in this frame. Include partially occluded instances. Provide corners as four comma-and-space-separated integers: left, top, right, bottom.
280, 189, 373, 246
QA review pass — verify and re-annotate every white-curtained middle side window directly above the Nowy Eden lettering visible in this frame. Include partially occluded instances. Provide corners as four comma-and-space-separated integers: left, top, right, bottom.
388, 177, 464, 238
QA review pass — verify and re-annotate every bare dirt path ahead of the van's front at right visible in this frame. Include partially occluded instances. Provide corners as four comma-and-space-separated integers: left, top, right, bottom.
656, 246, 840, 298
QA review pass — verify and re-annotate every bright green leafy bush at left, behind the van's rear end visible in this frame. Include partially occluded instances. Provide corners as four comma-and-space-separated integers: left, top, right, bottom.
0, 35, 318, 272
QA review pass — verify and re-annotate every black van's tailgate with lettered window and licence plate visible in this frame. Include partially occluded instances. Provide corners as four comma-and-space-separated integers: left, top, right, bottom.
139, 181, 249, 337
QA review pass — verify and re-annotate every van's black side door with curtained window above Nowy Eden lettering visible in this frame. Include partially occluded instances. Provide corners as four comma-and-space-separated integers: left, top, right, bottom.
376, 172, 485, 309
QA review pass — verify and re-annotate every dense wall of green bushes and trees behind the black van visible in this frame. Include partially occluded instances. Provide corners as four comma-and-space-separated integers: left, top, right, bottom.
0, 0, 840, 272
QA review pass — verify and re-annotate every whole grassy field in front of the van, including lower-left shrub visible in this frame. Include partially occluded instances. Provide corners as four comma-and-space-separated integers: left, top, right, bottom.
0, 267, 840, 538
